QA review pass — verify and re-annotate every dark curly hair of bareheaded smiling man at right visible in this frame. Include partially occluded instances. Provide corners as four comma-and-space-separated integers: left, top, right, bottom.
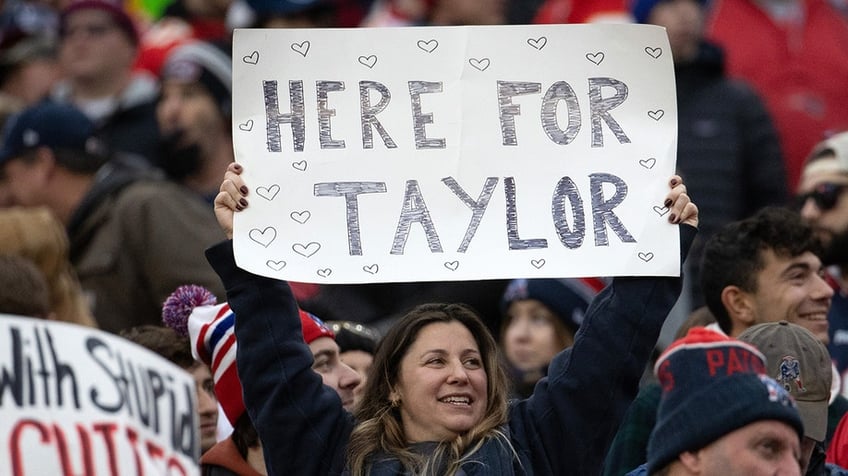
701, 207, 822, 333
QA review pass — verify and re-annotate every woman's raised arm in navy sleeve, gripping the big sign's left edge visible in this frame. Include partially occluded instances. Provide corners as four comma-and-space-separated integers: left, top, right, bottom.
206, 164, 353, 475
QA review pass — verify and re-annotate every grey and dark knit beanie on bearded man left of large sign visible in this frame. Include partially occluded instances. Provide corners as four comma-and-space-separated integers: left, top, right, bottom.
162, 41, 233, 118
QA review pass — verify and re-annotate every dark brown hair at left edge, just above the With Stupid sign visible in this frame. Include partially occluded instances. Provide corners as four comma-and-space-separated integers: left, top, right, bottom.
0, 255, 51, 318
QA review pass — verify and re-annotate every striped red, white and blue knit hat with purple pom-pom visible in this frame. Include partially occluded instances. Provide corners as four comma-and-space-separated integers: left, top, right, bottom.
162, 285, 333, 425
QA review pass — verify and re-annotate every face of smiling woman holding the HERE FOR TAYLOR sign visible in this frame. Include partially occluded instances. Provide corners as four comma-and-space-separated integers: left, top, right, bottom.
390, 321, 488, 443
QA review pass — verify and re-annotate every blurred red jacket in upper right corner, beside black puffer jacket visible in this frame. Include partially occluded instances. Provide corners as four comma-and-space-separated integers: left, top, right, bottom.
707, 0, 848, 190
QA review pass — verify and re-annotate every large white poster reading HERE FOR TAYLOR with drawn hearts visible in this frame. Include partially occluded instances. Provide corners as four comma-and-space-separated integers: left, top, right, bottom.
233, 24, 679, 283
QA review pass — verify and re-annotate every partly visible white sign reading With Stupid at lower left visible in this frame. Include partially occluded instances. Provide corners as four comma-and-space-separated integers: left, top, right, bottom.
0, 315, 200, 476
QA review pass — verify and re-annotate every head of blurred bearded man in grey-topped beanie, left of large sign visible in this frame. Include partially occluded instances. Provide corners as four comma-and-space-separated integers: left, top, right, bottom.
156, 41, 233, 203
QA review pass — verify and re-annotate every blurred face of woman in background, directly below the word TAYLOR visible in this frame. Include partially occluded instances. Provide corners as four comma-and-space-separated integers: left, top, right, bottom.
503, 299, 573, 372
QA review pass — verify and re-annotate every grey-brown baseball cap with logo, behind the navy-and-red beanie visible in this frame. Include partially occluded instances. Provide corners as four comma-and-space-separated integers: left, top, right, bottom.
739, 321, 833, 442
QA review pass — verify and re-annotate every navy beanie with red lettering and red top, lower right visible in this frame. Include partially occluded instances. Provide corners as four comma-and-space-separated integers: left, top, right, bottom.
648, 327, 804, 474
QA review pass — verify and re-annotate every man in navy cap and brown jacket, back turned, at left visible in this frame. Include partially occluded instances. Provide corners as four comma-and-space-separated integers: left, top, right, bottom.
0, 103, 224, 333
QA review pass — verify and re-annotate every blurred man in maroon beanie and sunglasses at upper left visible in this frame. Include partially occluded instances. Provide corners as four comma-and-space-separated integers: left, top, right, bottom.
50, 0, 159, 161
